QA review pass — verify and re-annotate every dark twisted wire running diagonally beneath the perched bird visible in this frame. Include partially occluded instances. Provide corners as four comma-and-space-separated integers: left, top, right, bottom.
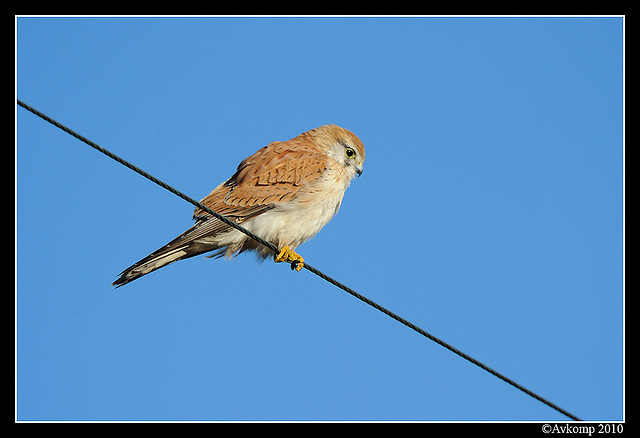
18, 99, 581, 421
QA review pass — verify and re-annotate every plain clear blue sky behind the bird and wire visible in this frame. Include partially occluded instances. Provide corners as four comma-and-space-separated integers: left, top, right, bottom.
16, 17, 624, 421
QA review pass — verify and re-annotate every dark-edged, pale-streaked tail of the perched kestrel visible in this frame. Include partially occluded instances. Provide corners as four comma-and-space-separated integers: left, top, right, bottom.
111, 227, 216, 287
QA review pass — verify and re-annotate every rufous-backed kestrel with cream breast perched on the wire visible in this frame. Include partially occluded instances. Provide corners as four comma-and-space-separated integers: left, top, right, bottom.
113, 125, 364, 286
